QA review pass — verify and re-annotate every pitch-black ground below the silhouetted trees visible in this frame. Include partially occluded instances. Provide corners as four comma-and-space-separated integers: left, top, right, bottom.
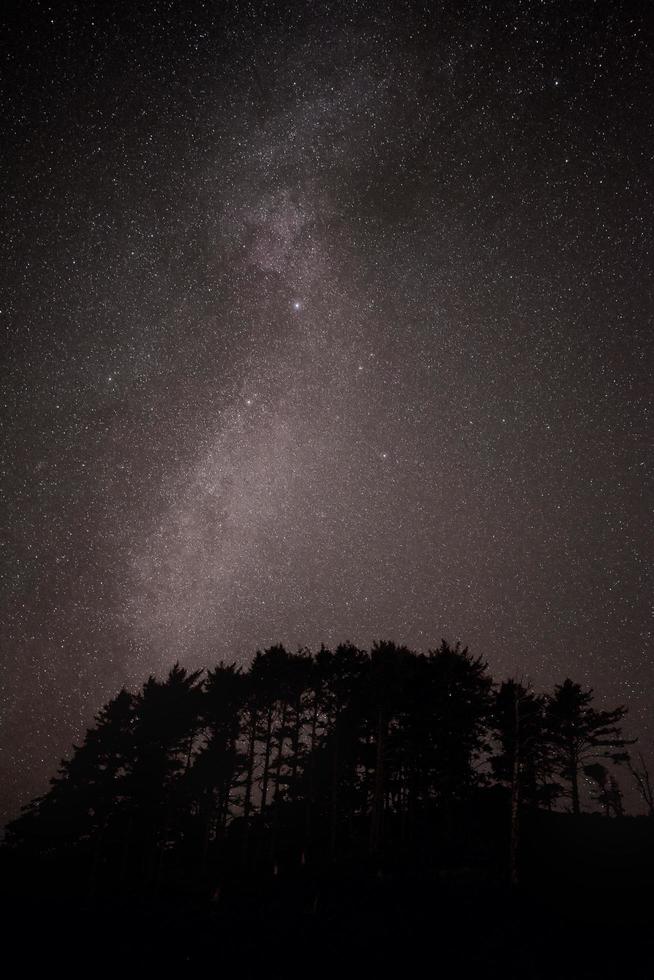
2, 818, 654, 980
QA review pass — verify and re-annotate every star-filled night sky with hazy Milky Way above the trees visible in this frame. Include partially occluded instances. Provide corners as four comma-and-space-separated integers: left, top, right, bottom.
0, 0, 654, 828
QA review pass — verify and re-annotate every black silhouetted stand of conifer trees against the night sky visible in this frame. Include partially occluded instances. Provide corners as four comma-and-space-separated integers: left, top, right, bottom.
6, 641, 653, 887
